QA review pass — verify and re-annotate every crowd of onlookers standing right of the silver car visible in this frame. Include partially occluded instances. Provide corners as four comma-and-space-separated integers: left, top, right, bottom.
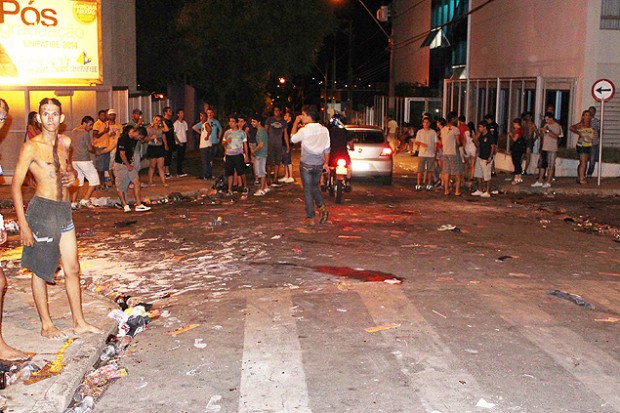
398, 107, 600, 198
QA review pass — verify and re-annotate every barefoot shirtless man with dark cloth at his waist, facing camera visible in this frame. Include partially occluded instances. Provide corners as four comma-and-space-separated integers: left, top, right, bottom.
11, 98, 101, 338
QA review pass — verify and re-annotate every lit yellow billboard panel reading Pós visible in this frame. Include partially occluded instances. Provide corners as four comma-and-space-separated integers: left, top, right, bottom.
0, 0, 102, 86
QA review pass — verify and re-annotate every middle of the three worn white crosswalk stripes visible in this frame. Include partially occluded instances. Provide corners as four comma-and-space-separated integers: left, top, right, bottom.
356, 284, 483, 412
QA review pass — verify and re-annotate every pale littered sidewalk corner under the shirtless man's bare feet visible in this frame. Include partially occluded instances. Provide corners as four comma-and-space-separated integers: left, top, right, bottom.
0, 284, 116, 413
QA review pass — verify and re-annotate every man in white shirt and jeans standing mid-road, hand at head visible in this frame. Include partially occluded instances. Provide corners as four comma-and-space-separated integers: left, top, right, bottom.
291, 106, 330, 225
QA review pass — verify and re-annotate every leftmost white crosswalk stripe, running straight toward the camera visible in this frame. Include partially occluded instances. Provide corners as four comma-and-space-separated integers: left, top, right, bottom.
239, 289, 311, 413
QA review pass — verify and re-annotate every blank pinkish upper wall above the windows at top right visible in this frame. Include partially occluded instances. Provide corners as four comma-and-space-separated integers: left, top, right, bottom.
470, 0, 588, 78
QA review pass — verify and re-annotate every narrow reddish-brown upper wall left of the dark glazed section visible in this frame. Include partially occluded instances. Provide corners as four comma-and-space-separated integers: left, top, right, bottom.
392, 0, 431, 85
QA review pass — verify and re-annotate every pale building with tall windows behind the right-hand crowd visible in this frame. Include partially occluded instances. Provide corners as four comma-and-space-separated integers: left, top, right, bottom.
394, 0, 620, 147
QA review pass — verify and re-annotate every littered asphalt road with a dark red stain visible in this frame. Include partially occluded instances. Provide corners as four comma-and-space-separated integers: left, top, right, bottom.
58, 161, 620, 413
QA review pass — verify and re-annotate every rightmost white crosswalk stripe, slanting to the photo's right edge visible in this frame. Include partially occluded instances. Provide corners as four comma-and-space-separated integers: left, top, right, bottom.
479, 280, 620, 411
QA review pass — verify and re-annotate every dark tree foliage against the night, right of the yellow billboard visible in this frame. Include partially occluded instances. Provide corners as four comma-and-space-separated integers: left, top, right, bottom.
138, 0, 334, 110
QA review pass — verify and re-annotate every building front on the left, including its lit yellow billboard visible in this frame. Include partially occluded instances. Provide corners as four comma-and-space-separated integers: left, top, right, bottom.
0, 0, 138, 174
